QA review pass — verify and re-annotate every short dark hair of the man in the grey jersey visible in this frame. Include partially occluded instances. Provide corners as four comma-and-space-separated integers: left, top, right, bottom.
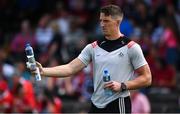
100, 5, 123, 17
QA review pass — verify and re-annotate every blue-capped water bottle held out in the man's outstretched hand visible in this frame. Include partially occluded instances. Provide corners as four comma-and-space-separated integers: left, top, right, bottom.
25, 43, 41, 81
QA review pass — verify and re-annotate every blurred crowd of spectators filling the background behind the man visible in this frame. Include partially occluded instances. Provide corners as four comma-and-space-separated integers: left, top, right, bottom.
0, 0, 180, 112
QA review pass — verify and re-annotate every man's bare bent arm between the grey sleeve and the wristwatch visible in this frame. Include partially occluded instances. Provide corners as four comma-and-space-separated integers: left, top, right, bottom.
125, 64, 152, 90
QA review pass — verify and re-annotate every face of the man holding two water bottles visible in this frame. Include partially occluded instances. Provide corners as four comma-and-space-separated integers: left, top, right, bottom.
100, 13, 119, 37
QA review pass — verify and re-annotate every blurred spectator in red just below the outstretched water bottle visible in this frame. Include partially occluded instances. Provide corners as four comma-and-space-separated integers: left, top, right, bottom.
12, 74, 36, 113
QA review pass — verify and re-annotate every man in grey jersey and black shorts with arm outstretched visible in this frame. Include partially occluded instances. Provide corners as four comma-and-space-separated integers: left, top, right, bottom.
28, 5, 151, 113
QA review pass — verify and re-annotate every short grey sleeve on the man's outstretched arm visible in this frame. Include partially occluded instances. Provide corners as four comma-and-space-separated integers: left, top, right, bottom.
78, 44, 92, 66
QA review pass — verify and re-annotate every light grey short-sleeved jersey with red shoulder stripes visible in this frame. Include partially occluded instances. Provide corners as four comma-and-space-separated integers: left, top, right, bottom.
78, 37, 147, 108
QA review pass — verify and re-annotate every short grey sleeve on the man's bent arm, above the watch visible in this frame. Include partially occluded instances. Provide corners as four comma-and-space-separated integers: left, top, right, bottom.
129, 43, 147, 69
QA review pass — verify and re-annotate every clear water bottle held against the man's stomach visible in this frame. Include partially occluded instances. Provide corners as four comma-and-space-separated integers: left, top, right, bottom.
103, 69, 113, 96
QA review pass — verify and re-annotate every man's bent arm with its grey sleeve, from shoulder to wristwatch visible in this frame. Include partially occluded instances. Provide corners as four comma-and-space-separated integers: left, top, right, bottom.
125, 41, 152, 90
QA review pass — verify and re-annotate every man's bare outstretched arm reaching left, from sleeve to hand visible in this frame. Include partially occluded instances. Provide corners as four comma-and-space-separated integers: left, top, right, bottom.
37, 58, 85, 77
